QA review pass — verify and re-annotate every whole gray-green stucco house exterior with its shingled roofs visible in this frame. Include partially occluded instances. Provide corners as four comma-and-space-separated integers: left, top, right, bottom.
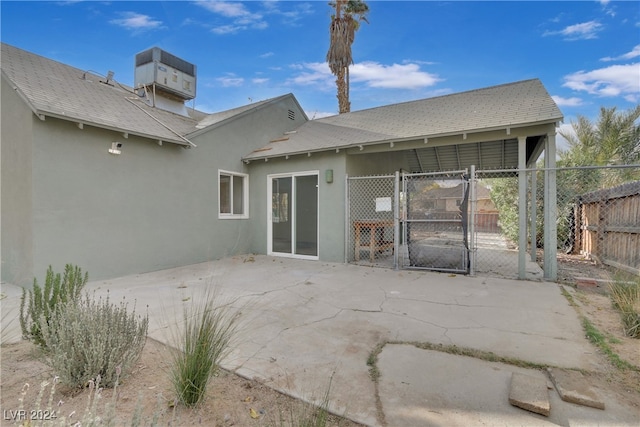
0, 44, 562, 286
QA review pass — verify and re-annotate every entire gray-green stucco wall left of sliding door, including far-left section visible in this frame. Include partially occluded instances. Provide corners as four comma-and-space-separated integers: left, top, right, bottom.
1, 47, 306, 285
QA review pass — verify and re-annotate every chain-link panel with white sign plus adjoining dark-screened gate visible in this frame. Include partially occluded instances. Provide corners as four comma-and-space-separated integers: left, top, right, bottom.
345, 170, 470, 274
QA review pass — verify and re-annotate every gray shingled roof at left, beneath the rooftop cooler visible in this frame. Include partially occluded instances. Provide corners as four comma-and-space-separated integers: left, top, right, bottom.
1, 43, 300, 147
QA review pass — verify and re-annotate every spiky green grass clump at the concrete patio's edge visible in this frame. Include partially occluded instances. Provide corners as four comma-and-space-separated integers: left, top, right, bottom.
170, 292, 238, 407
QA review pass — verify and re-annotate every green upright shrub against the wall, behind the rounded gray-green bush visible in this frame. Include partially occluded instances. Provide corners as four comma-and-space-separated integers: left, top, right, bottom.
20, 264, 89, 347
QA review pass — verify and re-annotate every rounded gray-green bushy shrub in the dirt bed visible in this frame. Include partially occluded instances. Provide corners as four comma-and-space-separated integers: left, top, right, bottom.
41, 295, 149, 387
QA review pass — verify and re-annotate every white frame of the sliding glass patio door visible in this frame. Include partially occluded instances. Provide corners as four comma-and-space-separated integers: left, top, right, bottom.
267, 170, 320, 261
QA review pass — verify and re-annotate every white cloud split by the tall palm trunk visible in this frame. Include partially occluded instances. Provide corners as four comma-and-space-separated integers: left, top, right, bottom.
290, 61, 442, 89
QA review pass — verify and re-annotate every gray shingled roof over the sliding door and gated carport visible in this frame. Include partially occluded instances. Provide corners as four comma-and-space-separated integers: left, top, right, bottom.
245, 79, 563, 160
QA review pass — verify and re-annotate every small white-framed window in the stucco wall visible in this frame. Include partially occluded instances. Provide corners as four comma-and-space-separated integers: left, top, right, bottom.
218, 171, 249, 219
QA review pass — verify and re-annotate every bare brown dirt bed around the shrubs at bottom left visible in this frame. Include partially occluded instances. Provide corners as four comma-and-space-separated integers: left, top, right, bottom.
0, 339, 364, 427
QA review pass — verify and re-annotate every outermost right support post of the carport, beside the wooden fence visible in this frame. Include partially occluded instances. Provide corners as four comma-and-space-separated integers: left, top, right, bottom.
544, 134, 558, 281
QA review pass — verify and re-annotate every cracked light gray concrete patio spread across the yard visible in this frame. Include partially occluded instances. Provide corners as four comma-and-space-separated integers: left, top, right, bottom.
2, 256, 637, 426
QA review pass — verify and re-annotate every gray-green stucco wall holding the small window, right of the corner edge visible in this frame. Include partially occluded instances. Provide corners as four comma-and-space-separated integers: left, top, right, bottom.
21, 95, 303, 279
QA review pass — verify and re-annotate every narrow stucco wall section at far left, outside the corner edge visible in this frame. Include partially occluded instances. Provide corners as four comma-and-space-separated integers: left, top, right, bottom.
0, 78, 33, 285
